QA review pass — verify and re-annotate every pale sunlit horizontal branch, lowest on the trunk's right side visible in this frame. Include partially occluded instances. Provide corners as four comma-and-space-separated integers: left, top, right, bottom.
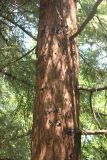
81, 130, 107, 135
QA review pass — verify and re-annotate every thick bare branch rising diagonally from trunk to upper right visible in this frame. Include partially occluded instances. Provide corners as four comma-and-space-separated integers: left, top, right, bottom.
70, 0, 103, 41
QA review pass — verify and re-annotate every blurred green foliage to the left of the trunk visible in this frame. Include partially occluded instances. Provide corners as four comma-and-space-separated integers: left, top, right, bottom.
0, 0, 38, 160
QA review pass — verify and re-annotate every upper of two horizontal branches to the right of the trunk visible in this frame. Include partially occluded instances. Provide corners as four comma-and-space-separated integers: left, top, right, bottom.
78, 86, 107, 93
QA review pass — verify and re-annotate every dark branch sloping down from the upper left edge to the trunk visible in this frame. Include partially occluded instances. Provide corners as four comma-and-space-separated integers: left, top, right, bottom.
0, 13, 36, 40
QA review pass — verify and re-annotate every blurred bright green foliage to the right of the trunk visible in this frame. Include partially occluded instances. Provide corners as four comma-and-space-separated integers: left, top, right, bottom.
78, 1, 107, 160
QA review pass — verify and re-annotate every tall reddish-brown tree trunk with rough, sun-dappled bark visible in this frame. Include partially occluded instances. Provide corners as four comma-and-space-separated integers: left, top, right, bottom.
32, 0, 80, 160
